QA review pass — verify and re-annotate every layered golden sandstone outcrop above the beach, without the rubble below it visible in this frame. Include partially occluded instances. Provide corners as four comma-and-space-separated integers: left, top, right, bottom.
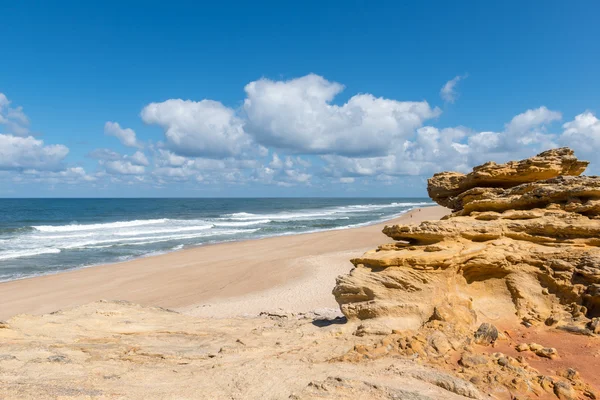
333, 149, 600, 332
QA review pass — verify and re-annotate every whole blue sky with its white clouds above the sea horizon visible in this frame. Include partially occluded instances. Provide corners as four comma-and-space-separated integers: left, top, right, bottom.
0, 1, 600, 197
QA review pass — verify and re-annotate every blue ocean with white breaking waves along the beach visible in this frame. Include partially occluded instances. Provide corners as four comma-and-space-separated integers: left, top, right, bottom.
0, 198, 433, 281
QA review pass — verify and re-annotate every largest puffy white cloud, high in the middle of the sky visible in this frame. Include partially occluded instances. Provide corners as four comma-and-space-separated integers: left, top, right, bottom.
244, 74, 440, 156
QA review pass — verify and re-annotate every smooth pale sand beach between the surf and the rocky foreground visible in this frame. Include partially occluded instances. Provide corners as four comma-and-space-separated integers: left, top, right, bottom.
0, 207, 449, 320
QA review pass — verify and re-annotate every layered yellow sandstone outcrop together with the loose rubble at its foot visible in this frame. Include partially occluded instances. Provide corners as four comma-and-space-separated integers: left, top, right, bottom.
333, 148, 600, 398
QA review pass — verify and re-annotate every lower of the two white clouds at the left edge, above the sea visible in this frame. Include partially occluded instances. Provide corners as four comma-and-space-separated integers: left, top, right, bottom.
0, 134, 69, 170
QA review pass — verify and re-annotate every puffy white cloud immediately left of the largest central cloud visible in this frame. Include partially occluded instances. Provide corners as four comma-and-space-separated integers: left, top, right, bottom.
141, 99, 255, 158
